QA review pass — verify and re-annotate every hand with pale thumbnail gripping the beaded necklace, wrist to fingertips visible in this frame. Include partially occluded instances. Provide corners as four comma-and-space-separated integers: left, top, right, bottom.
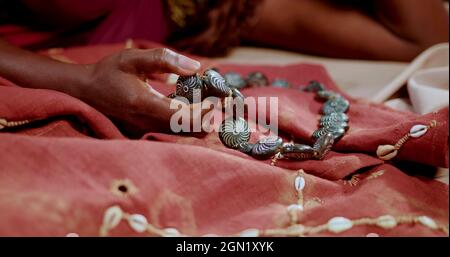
79, 48, 208, 134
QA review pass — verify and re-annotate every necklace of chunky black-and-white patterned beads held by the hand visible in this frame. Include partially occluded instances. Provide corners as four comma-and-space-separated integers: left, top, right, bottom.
169, 69, 350, 160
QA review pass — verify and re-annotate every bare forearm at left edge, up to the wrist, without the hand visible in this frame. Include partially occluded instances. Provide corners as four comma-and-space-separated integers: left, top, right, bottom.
0, 39, 88, 97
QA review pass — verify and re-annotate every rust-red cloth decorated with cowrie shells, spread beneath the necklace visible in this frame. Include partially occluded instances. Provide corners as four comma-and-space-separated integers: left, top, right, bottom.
0, 42, 449, 236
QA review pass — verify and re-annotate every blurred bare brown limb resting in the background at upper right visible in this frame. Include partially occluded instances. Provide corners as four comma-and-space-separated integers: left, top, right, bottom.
243, 0, 448, 61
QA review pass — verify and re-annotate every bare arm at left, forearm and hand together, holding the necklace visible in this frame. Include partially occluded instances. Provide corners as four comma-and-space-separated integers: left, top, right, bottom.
0, 40, 209, 135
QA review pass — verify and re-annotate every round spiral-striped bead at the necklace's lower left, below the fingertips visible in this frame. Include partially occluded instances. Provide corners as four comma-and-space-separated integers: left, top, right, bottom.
219, 118, 250, 148
